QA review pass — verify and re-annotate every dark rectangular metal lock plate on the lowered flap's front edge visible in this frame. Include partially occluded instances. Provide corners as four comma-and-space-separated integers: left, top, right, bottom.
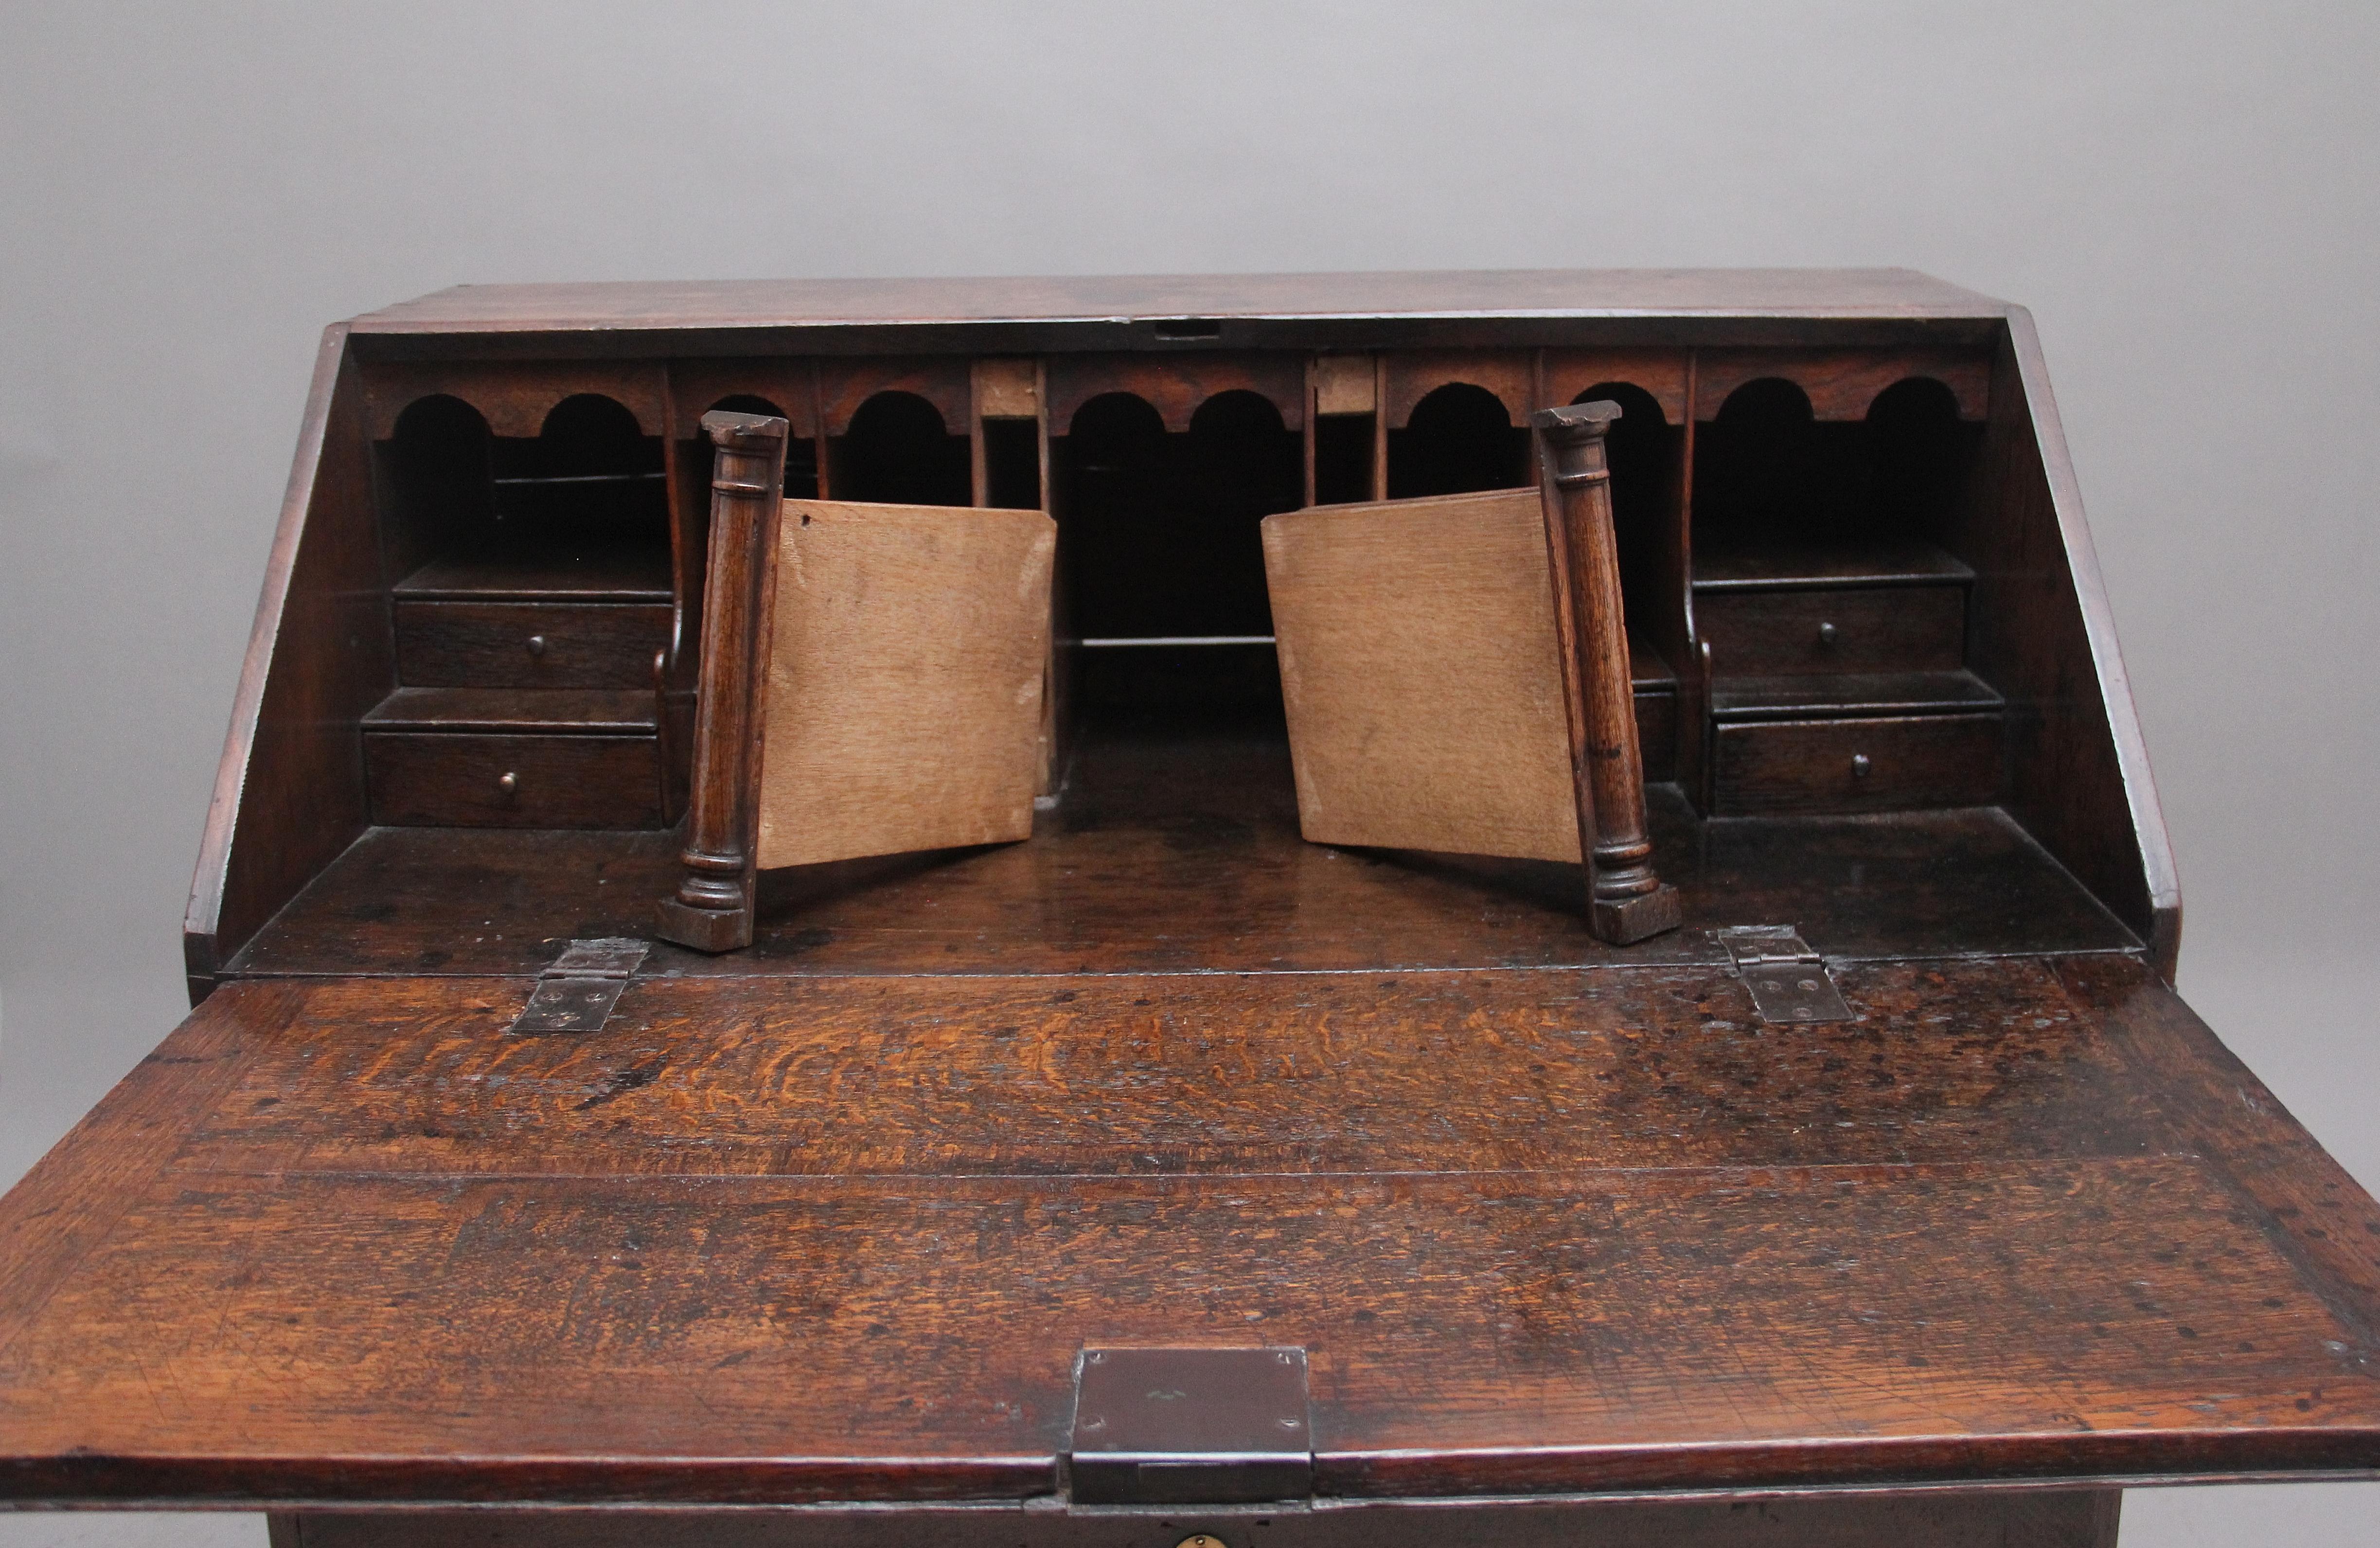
1068, 1346, 1314, 1505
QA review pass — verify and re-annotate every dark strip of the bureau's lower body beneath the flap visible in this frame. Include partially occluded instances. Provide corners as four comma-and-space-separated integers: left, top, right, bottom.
271, 1489, 2123, 1548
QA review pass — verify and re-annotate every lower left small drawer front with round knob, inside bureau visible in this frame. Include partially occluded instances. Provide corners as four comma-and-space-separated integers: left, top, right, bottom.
364, 731, 662, 829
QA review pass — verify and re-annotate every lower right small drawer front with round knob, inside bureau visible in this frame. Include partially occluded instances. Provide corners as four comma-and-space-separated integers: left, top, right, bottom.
1714, 714, 2002, 817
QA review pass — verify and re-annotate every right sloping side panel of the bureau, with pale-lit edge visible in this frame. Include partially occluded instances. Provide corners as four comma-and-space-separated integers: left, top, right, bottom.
1949, 307, 2183, 981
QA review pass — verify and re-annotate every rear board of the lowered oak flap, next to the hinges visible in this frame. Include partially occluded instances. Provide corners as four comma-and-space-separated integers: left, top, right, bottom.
183, 960, 2164, 1176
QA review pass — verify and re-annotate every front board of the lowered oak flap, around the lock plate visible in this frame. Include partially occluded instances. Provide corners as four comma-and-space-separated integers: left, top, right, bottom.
0, 1155, 2380, 1503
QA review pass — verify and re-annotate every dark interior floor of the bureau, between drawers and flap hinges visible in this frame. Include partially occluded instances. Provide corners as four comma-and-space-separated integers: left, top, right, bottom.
224, 731, 2137, 974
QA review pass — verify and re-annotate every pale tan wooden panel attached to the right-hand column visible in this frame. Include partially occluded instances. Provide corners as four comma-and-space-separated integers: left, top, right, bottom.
1264, 491, 1581, 865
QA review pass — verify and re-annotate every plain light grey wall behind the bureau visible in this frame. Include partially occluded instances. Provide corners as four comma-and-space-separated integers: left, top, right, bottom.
0, 0, 2380, 1548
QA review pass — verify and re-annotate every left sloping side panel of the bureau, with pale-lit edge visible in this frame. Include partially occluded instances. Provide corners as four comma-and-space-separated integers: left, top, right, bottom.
181, 326, 395, 1005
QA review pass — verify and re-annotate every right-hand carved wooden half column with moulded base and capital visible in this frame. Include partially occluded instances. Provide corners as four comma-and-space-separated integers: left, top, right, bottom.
1530, 403, 1678, 945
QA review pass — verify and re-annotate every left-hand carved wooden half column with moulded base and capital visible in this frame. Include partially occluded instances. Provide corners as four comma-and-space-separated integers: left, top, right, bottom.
659, 412, 788, 950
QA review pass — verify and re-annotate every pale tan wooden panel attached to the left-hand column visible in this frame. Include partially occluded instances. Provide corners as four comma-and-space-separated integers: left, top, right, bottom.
759, 500, 1057, 869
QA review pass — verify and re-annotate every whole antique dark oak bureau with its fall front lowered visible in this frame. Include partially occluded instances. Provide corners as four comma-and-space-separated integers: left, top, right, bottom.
0, 271, 2380, 1548
